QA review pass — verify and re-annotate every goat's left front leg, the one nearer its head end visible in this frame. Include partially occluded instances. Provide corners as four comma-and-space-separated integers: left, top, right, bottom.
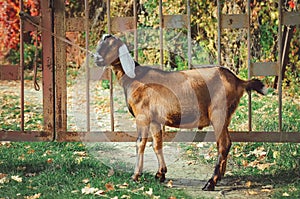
132, 124, 149, 181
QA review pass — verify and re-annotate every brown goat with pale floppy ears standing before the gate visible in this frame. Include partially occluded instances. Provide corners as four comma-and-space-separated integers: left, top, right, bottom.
95, 35, 266, 190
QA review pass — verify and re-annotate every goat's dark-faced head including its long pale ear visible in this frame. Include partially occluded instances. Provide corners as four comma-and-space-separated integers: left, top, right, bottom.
95, 34, 135, 78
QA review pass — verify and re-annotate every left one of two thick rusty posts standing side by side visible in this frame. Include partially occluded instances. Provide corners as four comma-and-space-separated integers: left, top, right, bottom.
40, 1, 55, 139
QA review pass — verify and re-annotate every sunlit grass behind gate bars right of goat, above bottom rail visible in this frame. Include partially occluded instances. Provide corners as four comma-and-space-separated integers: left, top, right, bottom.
229, 93, 300, 132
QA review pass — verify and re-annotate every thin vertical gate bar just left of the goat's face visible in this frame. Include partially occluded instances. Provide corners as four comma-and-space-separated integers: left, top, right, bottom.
84, 0, 91, 132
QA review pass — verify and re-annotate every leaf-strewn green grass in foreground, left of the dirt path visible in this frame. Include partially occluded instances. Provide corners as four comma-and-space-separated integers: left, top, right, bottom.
0, 142, 187, 198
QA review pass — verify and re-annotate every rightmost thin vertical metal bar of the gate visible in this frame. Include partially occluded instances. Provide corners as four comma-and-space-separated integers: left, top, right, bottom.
277, 0, 282, 132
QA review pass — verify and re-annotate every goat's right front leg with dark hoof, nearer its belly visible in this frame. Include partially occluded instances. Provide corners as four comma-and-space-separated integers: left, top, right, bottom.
150, 122, 167, 182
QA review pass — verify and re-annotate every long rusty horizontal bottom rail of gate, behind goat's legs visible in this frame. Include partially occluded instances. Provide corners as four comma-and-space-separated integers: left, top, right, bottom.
0, 130, 300, 143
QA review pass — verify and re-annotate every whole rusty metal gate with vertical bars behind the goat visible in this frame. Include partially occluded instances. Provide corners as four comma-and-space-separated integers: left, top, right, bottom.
0, 0, 300, 143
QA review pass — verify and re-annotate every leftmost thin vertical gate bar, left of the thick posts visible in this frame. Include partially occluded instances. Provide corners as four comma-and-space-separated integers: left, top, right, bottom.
20, 0, 24, 131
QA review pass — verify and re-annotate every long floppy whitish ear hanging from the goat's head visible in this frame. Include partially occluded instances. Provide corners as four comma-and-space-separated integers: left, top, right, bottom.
119, 44, 135, 78
